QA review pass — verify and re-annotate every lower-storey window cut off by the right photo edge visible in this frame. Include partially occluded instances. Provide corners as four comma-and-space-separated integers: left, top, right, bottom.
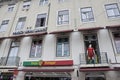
113, 33, 120, 53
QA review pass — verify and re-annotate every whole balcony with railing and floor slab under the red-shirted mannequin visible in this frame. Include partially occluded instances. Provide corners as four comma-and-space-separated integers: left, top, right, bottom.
80, 52, 109, 67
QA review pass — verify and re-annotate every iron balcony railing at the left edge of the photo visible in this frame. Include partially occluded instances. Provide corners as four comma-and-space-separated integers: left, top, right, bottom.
0, 56, 20, 66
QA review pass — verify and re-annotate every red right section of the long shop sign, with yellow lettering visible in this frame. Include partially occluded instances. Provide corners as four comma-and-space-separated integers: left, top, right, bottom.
42, 60, 73, 66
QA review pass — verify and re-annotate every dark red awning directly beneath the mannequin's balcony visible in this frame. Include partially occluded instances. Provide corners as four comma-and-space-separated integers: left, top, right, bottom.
80, 67, 113, 72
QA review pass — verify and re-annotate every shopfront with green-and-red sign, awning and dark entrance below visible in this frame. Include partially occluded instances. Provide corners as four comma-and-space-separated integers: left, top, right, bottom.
20, 60, 74, 80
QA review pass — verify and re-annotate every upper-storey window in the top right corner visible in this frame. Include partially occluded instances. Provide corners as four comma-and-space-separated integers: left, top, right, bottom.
105, 4, 120, 18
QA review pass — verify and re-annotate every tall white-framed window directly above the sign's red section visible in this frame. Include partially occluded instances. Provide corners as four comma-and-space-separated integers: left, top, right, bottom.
56, 38, 70, 57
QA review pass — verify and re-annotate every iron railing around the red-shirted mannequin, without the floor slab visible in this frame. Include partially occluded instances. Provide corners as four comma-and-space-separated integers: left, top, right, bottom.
80, 52, 108, 64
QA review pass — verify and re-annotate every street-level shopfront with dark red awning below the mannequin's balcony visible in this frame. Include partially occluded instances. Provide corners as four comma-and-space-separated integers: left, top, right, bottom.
80, 66, 117, 80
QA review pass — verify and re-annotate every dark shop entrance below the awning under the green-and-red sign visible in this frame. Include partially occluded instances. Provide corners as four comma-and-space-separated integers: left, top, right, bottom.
24, 72, 71, 80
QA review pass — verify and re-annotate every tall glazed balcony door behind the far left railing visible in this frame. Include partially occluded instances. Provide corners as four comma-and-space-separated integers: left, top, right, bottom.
6, 41, 20, 66
